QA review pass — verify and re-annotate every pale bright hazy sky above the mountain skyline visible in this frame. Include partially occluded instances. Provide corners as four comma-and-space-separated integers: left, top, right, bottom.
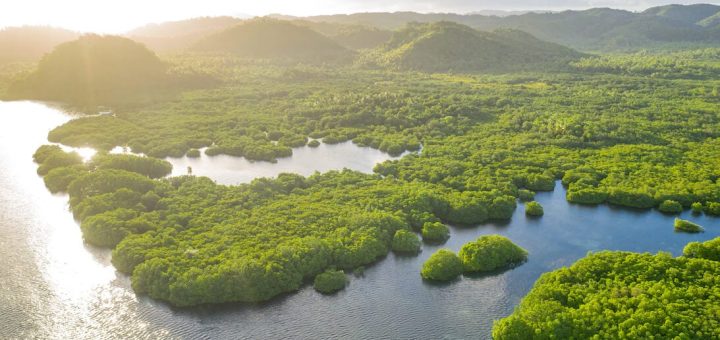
0, 0, 720, 33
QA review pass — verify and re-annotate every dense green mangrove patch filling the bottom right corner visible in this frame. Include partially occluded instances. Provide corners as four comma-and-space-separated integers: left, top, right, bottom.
493, 247, 720, 340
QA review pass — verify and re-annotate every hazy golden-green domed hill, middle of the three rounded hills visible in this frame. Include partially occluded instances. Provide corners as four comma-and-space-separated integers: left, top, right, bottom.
192, 18, 353, 63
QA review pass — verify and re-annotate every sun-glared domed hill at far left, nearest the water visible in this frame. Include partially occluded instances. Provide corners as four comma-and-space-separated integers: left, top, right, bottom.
9, 35, 173, 105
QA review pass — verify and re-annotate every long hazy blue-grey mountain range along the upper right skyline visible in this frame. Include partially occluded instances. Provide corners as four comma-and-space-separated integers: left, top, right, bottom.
290, 5, 720, 50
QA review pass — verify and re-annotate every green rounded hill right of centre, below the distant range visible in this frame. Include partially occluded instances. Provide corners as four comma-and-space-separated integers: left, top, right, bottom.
366, 21, 583, 72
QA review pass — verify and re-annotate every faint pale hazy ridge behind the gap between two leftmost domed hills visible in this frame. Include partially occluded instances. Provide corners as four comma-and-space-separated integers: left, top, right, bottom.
126, 17, 243, 51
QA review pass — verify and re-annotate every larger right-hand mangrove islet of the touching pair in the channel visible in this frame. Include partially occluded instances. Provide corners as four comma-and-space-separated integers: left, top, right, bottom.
458, 235, 528, 273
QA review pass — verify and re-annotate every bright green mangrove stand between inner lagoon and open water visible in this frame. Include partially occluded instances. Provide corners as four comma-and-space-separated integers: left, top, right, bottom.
36, 146, 536, 306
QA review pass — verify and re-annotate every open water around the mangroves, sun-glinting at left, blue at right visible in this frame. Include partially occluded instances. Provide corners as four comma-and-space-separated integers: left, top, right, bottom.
0, 102, 720, 339
